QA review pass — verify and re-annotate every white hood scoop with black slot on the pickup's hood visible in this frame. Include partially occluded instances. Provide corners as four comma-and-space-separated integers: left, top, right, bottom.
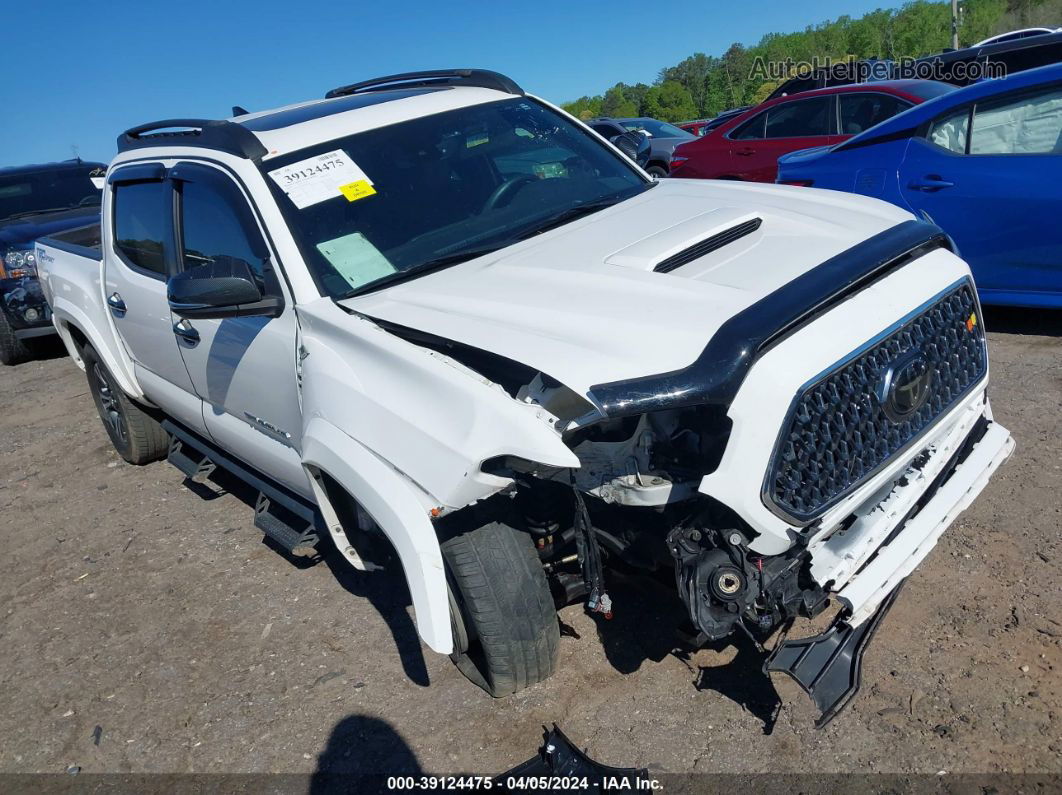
605, 207, 764, 273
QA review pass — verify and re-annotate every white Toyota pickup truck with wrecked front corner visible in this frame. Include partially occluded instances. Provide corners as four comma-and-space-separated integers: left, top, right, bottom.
37, 70, 1013, 723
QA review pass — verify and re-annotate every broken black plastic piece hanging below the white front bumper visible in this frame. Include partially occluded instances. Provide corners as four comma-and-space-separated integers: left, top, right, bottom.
764, 582, 904, 729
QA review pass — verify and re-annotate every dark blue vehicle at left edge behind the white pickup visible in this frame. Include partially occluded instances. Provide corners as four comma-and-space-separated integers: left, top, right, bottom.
0, 160, 107, 364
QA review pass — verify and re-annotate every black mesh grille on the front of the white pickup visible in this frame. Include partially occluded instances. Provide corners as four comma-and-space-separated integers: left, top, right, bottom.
765, 282, 988, 521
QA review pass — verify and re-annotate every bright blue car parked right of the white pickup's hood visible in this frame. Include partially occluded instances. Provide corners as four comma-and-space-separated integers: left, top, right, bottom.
777, 64, 1062, 309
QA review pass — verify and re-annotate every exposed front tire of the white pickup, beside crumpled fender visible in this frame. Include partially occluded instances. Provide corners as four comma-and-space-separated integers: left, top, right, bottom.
442, 522, 561, 697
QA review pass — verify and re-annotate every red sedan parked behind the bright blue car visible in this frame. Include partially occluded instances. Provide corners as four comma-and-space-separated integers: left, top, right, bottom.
670, 80, 955, 183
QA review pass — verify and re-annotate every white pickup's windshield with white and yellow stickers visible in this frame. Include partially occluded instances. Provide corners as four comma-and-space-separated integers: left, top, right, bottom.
262, 98, 654, 297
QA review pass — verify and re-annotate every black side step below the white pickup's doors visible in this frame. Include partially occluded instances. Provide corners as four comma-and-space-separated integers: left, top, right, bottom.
162, 419, 323, 557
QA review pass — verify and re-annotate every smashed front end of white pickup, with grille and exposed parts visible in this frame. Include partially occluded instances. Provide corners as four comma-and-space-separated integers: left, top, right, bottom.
356, 221, 1013, 726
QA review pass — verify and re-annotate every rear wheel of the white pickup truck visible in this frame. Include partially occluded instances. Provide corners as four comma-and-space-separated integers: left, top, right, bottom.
81, 345, 170, 465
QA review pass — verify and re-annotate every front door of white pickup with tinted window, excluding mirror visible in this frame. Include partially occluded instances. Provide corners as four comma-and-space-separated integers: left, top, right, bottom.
165, 163, 311, 497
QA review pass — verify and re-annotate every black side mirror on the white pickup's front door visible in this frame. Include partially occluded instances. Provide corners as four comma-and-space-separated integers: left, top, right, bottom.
166, 256, 284, 318
